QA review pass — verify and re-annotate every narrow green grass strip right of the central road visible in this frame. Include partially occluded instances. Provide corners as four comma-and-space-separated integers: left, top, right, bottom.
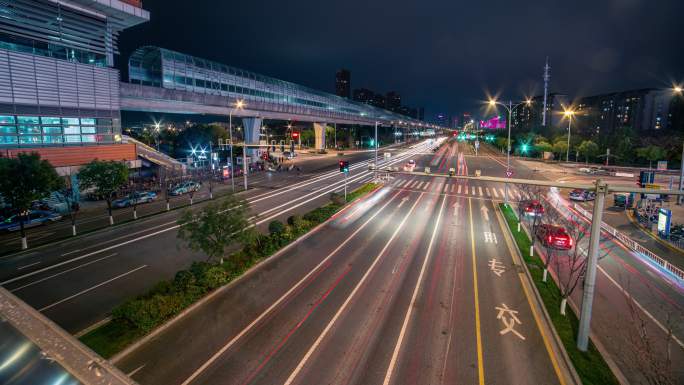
499, 203, 619, 385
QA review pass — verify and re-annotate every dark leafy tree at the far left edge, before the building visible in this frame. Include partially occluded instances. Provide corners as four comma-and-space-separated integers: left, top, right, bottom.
0, 153, 64, 249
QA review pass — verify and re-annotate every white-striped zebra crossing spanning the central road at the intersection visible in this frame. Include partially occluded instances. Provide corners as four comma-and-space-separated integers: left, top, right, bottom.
388, 178, 533, 201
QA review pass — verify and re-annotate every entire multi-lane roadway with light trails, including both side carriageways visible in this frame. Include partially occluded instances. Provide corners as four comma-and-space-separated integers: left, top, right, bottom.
0, 136, 684, 384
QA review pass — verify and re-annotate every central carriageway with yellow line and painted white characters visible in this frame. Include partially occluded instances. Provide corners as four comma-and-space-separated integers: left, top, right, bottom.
116, 141, 562, 384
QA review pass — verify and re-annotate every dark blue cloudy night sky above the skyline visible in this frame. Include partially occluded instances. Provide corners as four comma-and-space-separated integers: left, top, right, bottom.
119, 0, 684, 118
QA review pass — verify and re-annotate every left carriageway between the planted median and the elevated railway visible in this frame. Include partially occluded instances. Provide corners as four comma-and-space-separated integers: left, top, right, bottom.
0, 143, 427, 334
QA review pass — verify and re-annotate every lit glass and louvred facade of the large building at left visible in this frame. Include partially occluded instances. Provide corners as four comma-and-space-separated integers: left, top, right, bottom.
0, 0, 149, 147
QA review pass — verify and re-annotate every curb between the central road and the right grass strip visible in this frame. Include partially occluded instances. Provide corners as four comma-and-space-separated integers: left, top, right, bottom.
496, 205, 582, 385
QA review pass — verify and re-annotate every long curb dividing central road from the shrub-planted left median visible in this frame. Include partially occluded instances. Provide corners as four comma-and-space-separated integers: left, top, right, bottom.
109, 182, 381, 364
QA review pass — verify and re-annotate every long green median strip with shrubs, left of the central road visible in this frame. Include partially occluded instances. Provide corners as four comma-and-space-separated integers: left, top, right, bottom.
80, 183, 377, 358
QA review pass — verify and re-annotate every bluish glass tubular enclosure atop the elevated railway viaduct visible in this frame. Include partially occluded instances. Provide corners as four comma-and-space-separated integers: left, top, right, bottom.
128, 46, 417, 123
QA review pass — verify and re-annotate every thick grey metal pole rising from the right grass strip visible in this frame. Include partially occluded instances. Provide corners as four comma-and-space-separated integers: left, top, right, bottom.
577, 179, 608, 352
